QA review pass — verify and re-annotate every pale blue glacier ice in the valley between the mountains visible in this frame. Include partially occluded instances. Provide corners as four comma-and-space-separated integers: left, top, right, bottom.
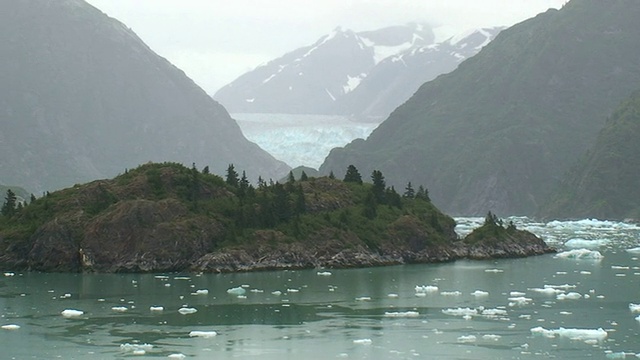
232, 114, 378, 169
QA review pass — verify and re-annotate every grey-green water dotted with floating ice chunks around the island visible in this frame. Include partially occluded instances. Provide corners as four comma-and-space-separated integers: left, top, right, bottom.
0, 218, 640, 359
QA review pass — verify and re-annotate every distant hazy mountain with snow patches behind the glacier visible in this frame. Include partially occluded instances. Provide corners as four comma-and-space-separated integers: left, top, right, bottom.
214, 24, 501, 119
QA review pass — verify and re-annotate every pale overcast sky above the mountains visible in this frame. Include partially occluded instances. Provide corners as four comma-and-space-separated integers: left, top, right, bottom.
88, 0, 566, 95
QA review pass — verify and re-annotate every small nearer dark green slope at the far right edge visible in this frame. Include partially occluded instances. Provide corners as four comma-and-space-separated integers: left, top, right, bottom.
540, 91, 640, 219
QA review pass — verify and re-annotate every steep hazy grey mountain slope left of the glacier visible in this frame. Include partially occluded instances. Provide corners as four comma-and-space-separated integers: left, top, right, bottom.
0, 0, 288, 192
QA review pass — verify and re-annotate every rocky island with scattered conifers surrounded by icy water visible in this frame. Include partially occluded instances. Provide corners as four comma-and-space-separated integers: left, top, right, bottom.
0, 163, 554, 272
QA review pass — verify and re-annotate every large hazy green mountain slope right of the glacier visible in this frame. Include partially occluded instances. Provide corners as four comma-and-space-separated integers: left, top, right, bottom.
321, 0, 640, 215
